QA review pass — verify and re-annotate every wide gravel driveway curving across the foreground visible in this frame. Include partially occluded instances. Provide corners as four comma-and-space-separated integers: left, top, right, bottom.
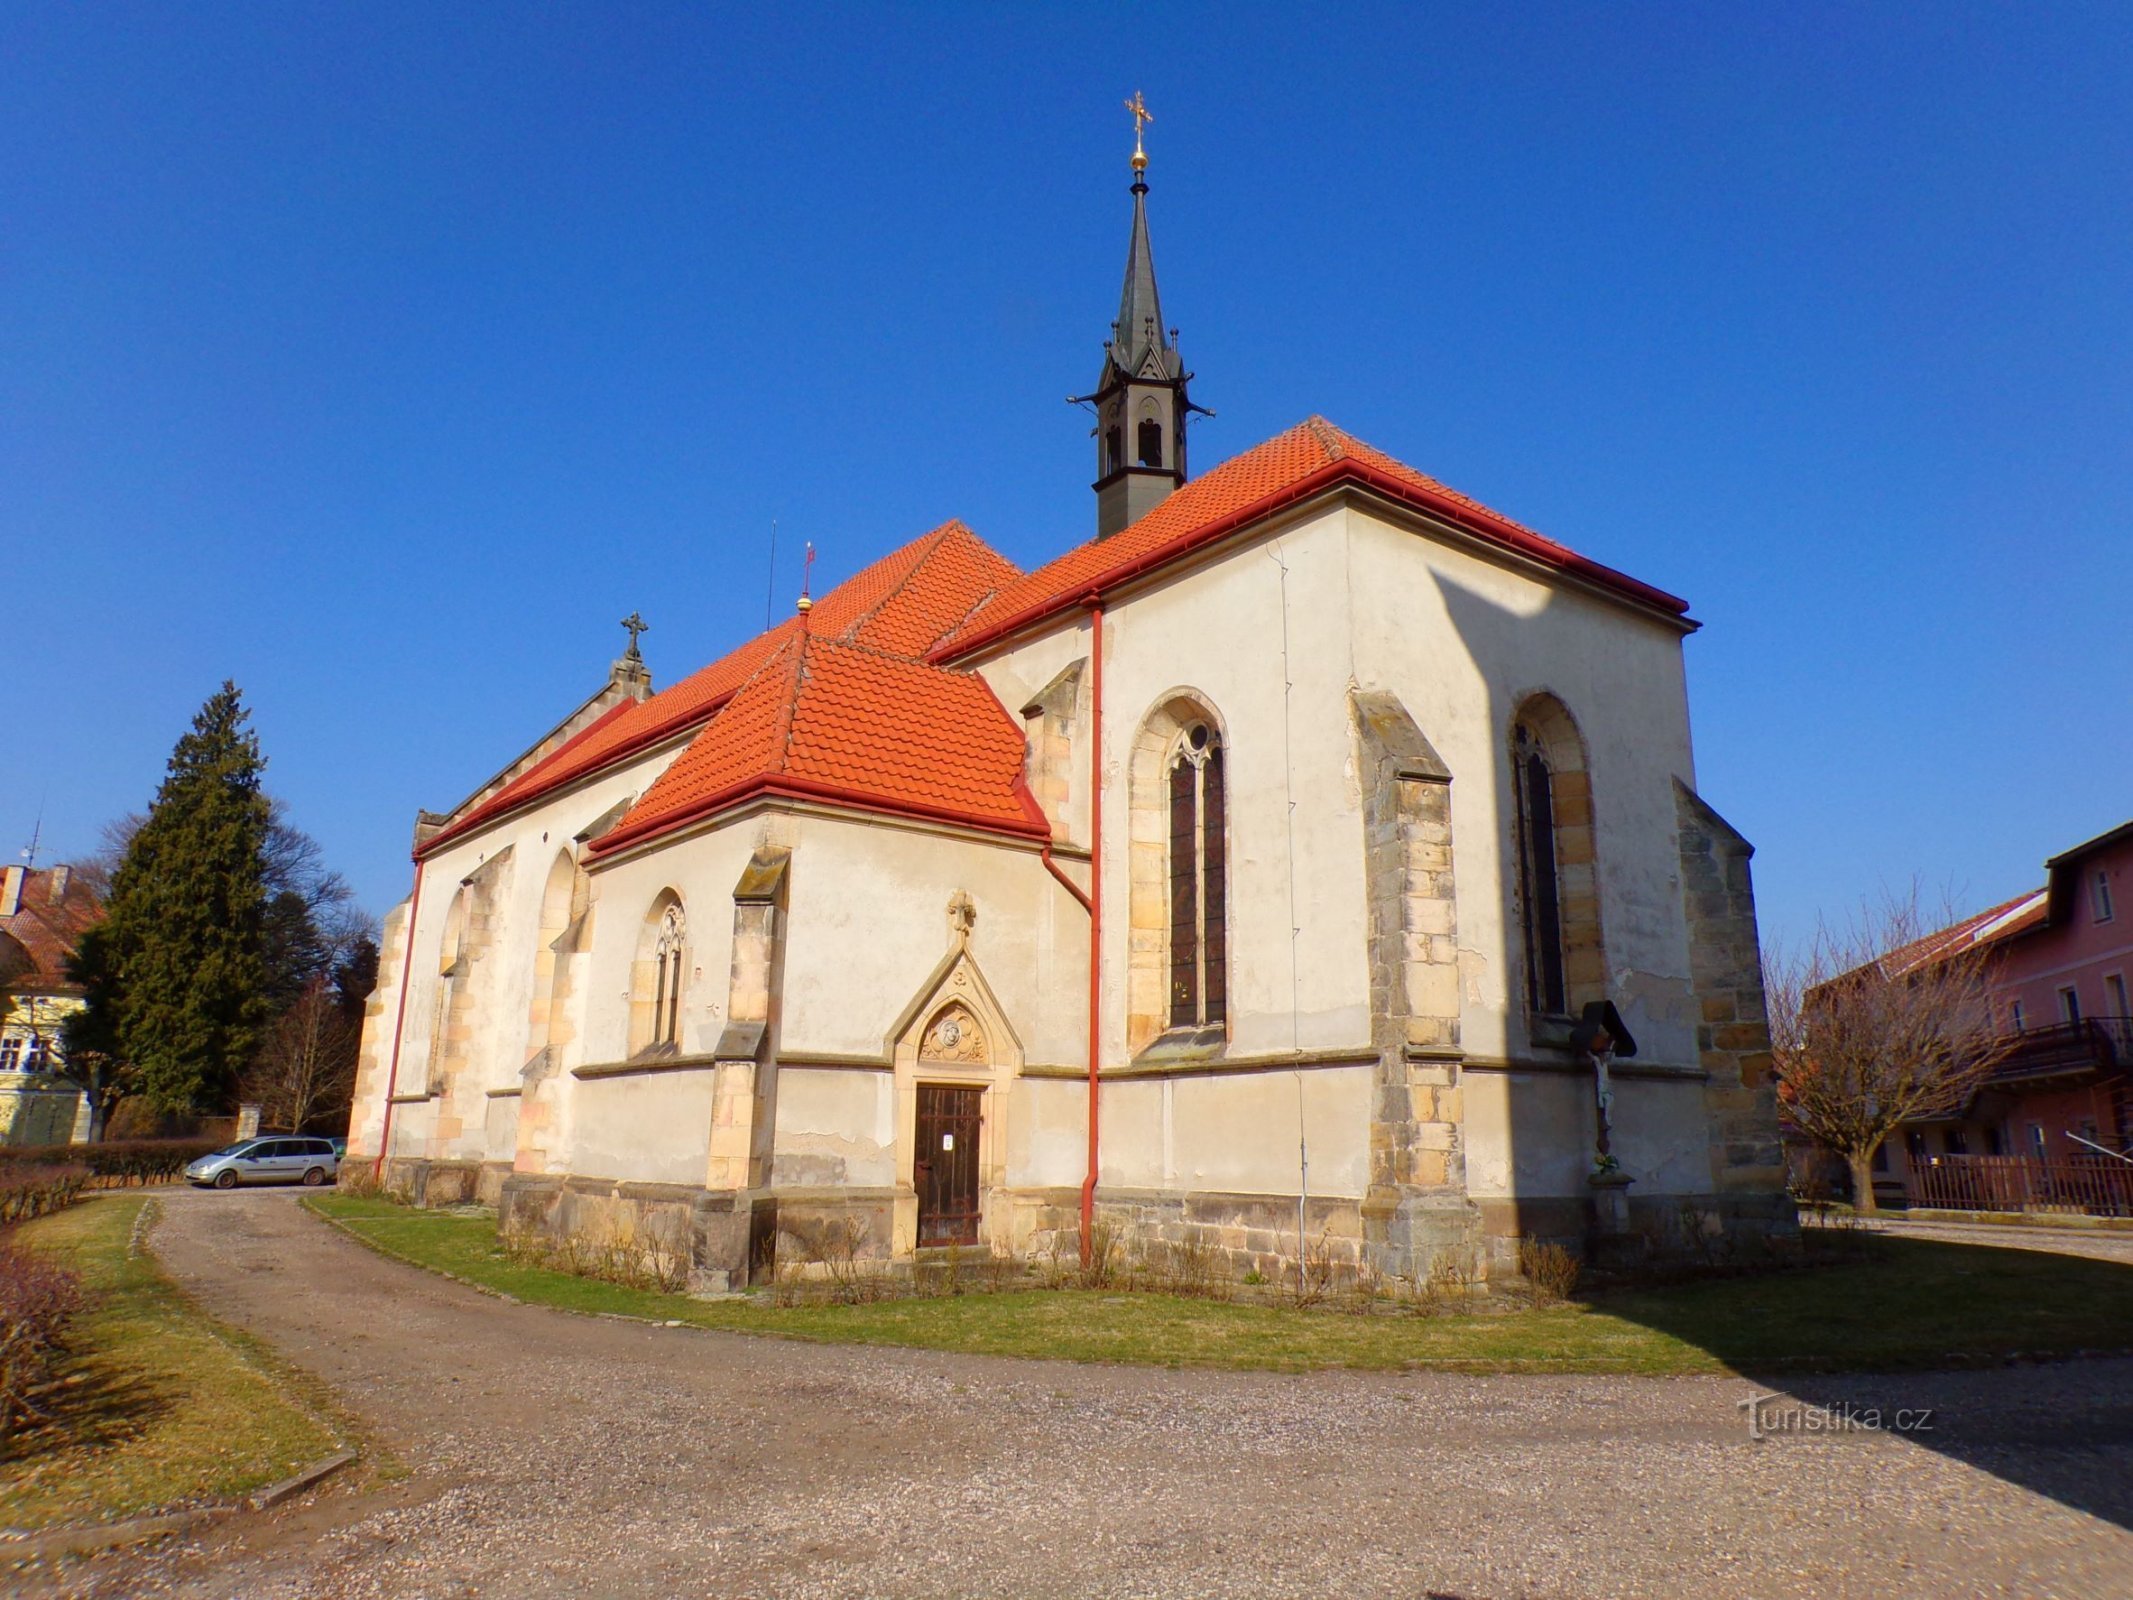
41, 1193, 2133, 1600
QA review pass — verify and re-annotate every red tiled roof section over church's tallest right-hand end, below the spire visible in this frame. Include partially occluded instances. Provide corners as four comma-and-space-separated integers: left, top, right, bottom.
932, 416, 1687, 661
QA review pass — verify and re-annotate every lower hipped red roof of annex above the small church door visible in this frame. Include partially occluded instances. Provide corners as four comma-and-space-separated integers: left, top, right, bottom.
593, 631, 1049, 853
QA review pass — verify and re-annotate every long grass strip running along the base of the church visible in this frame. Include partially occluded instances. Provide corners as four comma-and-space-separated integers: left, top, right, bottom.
305, 1195, 2133, 1374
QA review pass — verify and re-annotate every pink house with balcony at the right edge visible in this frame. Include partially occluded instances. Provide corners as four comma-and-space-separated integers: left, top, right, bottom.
1875, 821, 2133, 1210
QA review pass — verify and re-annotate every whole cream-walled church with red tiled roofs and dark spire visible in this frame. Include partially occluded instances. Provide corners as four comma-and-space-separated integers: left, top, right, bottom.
350, 122, 1792, 1289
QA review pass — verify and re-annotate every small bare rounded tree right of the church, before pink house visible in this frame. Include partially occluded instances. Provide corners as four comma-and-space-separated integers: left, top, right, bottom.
1764, 890, 2014, 1212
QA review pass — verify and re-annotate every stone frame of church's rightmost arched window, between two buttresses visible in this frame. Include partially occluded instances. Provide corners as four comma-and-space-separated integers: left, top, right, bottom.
1504, 689, 1606, 1022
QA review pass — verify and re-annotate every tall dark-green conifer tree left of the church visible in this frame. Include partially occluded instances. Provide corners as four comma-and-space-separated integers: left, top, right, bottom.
105, 683, 271, 1111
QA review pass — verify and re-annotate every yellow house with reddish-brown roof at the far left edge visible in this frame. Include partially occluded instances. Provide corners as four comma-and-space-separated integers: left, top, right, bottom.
0, 866, 105, 1146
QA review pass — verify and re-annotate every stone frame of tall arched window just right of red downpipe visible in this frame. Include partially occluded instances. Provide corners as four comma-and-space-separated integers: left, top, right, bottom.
1126, 687, 1237, 1058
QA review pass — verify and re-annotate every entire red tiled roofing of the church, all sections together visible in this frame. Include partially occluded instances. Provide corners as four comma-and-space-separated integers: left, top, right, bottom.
418, 416, 1687, 855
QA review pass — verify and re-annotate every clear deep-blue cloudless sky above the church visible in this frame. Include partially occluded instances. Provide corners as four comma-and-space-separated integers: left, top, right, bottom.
0, 2, 2133, 951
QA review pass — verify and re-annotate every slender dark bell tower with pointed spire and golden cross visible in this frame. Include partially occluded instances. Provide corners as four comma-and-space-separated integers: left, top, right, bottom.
1075, 92, 1212, 540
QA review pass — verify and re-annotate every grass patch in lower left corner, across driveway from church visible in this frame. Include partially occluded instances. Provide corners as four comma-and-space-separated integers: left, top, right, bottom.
0, 1195, 341, 1530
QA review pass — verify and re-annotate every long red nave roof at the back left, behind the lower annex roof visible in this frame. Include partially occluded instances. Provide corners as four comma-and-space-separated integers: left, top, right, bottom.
416, 523, 1020, 855
